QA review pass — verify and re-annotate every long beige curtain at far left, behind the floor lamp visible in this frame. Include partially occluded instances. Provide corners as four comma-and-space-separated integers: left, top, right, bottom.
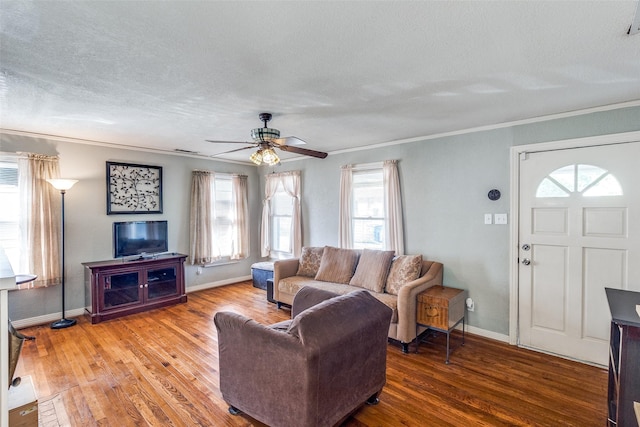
17, 153, 62, 287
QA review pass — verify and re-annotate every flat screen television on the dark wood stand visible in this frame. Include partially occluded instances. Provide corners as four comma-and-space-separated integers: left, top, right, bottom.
113, 221, 169, 258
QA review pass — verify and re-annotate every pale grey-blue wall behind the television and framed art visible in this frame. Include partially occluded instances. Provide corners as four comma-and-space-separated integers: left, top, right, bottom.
0, 134, 262, 321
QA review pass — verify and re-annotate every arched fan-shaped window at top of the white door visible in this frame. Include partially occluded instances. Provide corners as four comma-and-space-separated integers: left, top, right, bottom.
536, 165, 623, 198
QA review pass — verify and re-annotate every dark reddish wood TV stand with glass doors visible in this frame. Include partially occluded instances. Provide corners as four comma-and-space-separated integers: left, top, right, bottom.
82, 253, 187, 323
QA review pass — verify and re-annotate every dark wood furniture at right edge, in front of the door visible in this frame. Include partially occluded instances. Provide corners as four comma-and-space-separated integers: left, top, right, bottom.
605, 288, 640, 427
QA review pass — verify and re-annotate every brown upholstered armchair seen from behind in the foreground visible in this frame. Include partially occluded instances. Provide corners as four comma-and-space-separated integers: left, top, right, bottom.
214, 287, 391, 427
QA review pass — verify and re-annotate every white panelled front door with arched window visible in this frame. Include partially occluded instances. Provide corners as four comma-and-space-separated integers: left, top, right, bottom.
518, 142, 640, 365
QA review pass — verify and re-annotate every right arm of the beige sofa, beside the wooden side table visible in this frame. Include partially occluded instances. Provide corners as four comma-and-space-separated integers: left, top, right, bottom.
396, 262, 443, 343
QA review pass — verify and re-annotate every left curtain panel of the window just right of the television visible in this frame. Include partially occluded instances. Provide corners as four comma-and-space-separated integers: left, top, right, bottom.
189, 171, 214, 265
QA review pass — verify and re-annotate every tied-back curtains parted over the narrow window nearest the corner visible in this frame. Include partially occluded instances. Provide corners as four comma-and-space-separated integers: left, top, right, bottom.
260, 171, 302, 257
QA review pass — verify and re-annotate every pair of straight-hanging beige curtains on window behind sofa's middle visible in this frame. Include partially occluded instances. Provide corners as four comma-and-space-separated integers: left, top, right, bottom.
338, 160, 404, 255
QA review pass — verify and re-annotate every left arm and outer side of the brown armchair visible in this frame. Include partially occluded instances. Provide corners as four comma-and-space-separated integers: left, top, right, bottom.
214, 312, 307, 422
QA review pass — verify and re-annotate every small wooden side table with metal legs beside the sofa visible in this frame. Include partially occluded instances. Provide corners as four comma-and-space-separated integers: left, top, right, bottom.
416, 286, 467, 365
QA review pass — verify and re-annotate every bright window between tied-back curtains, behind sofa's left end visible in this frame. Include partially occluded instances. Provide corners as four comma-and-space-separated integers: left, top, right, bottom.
271, 184, 294, 254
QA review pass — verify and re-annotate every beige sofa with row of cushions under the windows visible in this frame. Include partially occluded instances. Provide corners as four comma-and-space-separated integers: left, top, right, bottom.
273, 246, 443, 353
